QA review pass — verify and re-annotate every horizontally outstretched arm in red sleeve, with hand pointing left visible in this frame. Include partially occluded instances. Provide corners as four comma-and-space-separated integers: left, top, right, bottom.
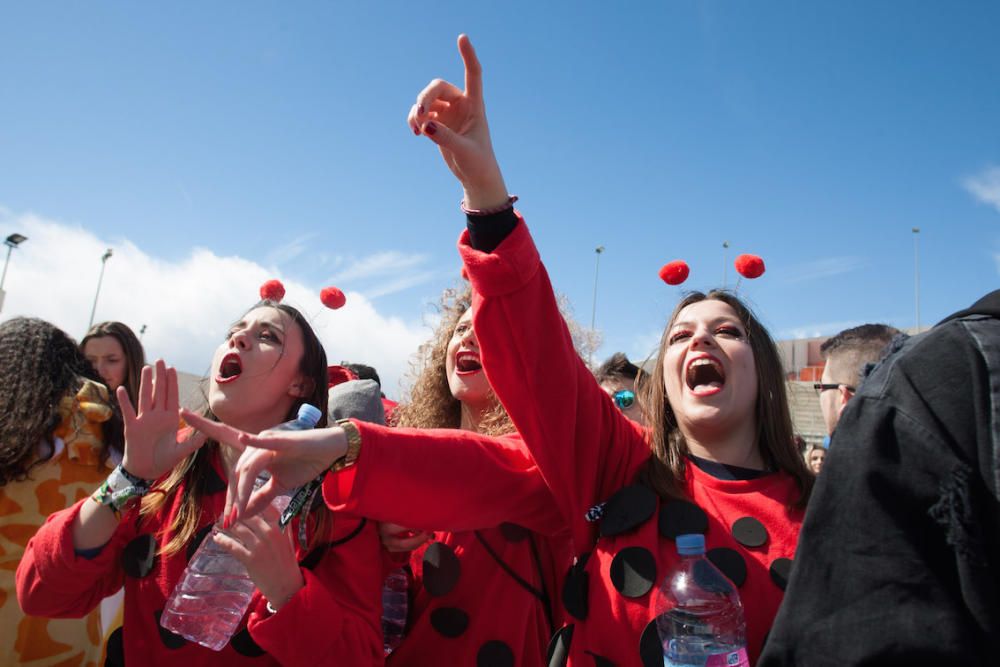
185, 413, 564, 534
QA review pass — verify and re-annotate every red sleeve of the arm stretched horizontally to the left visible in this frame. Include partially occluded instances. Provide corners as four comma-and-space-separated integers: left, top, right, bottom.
323, 420, 565, 535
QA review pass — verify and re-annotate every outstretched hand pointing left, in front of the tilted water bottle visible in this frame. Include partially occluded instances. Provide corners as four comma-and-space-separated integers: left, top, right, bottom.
181, 410, 347, 522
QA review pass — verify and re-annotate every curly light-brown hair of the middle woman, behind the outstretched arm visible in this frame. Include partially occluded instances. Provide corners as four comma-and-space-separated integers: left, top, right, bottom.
393, 287, 515, 436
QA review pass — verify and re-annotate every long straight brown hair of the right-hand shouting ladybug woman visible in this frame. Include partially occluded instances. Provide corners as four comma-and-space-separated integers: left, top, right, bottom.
642, 290, 814, 507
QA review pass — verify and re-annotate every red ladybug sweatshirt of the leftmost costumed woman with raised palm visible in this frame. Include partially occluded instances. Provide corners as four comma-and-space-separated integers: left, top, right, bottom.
17, 450, 383, 667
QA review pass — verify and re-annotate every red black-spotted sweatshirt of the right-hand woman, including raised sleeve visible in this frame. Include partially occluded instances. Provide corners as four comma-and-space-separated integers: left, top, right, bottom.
459, 220, 802, 666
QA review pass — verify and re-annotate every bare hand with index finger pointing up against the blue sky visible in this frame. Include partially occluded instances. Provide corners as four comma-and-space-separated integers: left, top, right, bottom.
407, 35, 509, 209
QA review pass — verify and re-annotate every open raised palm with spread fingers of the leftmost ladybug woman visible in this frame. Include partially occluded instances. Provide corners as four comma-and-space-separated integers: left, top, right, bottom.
117, 359, 205, 480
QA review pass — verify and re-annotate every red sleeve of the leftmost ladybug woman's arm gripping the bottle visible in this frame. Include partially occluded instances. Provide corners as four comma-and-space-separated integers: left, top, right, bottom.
247, 522, 384, 665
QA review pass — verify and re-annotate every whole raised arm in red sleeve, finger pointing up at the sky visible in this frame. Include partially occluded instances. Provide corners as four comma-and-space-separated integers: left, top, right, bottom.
408, 35, 649, 541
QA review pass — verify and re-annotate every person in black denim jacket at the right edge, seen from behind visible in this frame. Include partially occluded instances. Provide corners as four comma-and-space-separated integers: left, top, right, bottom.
760, 291, 1000, 667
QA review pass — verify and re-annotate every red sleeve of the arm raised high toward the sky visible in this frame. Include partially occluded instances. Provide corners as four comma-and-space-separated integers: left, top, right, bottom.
459, 220, 649, 545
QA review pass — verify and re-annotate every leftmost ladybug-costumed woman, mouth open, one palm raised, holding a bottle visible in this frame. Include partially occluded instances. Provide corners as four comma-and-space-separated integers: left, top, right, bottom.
17, 301, 383, 667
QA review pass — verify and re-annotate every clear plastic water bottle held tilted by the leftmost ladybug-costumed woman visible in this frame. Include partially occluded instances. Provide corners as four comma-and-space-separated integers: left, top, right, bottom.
160, 404, 323, 651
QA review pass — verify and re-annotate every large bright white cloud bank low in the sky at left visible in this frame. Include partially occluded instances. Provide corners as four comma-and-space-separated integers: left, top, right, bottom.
0, 209, 430, 396
